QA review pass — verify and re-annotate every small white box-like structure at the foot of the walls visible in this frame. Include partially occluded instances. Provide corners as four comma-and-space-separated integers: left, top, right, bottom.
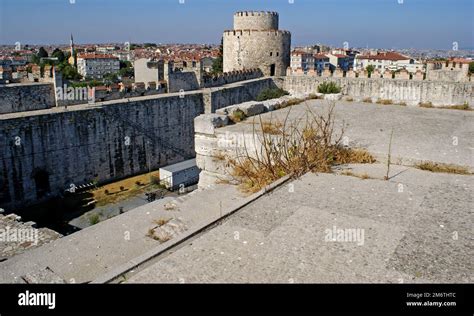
160, 159, 201, 190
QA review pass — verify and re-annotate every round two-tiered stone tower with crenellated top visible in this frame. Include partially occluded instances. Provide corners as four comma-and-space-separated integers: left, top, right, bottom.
224, 11, 291, 76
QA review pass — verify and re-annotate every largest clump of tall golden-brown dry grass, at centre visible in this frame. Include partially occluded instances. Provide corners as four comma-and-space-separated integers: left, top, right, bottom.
228, 102, 375, 192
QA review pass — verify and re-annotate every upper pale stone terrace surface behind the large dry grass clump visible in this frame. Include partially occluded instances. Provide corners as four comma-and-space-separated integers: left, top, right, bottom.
216, 100, 474, 168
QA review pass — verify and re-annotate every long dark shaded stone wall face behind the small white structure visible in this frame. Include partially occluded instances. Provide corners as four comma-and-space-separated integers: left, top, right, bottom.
0, 93, 204, 210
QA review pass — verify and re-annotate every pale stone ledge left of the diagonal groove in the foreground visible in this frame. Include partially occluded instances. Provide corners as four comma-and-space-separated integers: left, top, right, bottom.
0, 185, 256, 283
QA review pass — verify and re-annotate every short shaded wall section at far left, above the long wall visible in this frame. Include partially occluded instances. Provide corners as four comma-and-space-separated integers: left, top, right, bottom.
0, 83, 55, 114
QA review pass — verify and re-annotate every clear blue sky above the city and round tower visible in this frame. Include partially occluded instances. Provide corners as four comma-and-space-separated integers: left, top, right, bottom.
0, 0, 474, 49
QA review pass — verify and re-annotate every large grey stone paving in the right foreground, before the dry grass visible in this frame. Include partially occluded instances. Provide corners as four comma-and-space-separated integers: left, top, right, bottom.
126, 165, 474, 283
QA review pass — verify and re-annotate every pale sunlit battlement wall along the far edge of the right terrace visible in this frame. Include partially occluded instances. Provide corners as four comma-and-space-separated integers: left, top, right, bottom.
282, 76, 474, 107
